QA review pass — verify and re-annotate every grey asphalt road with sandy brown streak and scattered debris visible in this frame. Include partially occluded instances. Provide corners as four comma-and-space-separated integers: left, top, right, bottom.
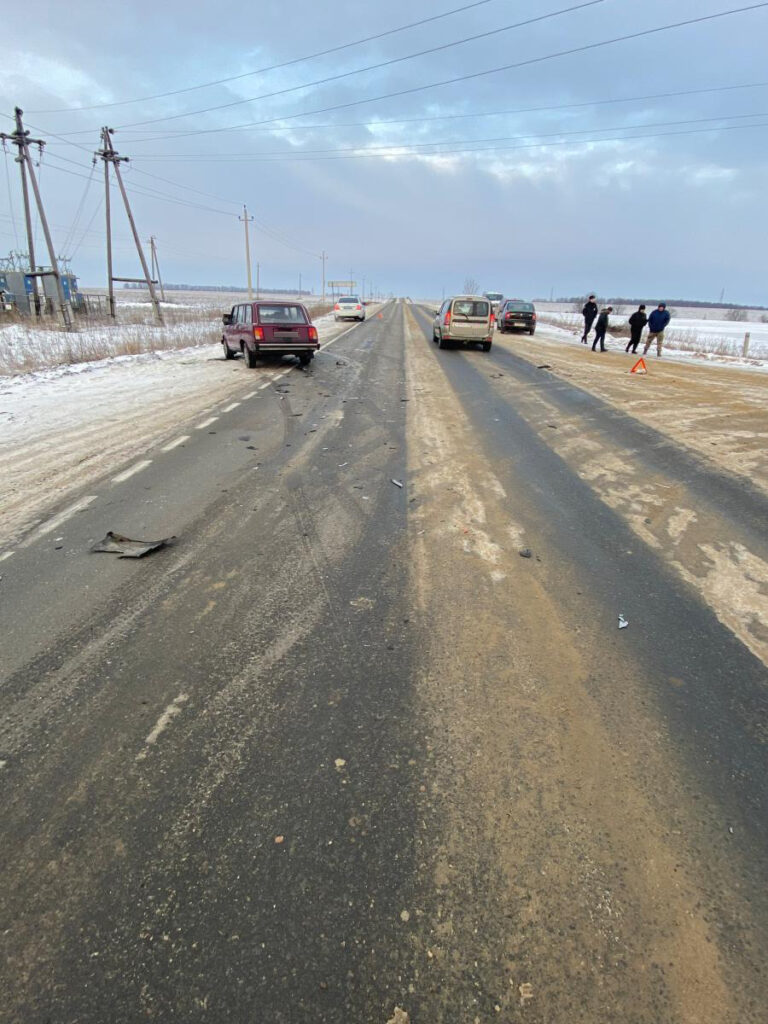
0, 303, 768, 1024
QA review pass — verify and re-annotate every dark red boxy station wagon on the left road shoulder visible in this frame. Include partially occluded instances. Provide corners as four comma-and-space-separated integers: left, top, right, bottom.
221, 300, 319, 369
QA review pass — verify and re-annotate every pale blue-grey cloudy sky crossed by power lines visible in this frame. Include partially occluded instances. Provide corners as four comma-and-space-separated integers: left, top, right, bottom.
0, 0, 768, 303
